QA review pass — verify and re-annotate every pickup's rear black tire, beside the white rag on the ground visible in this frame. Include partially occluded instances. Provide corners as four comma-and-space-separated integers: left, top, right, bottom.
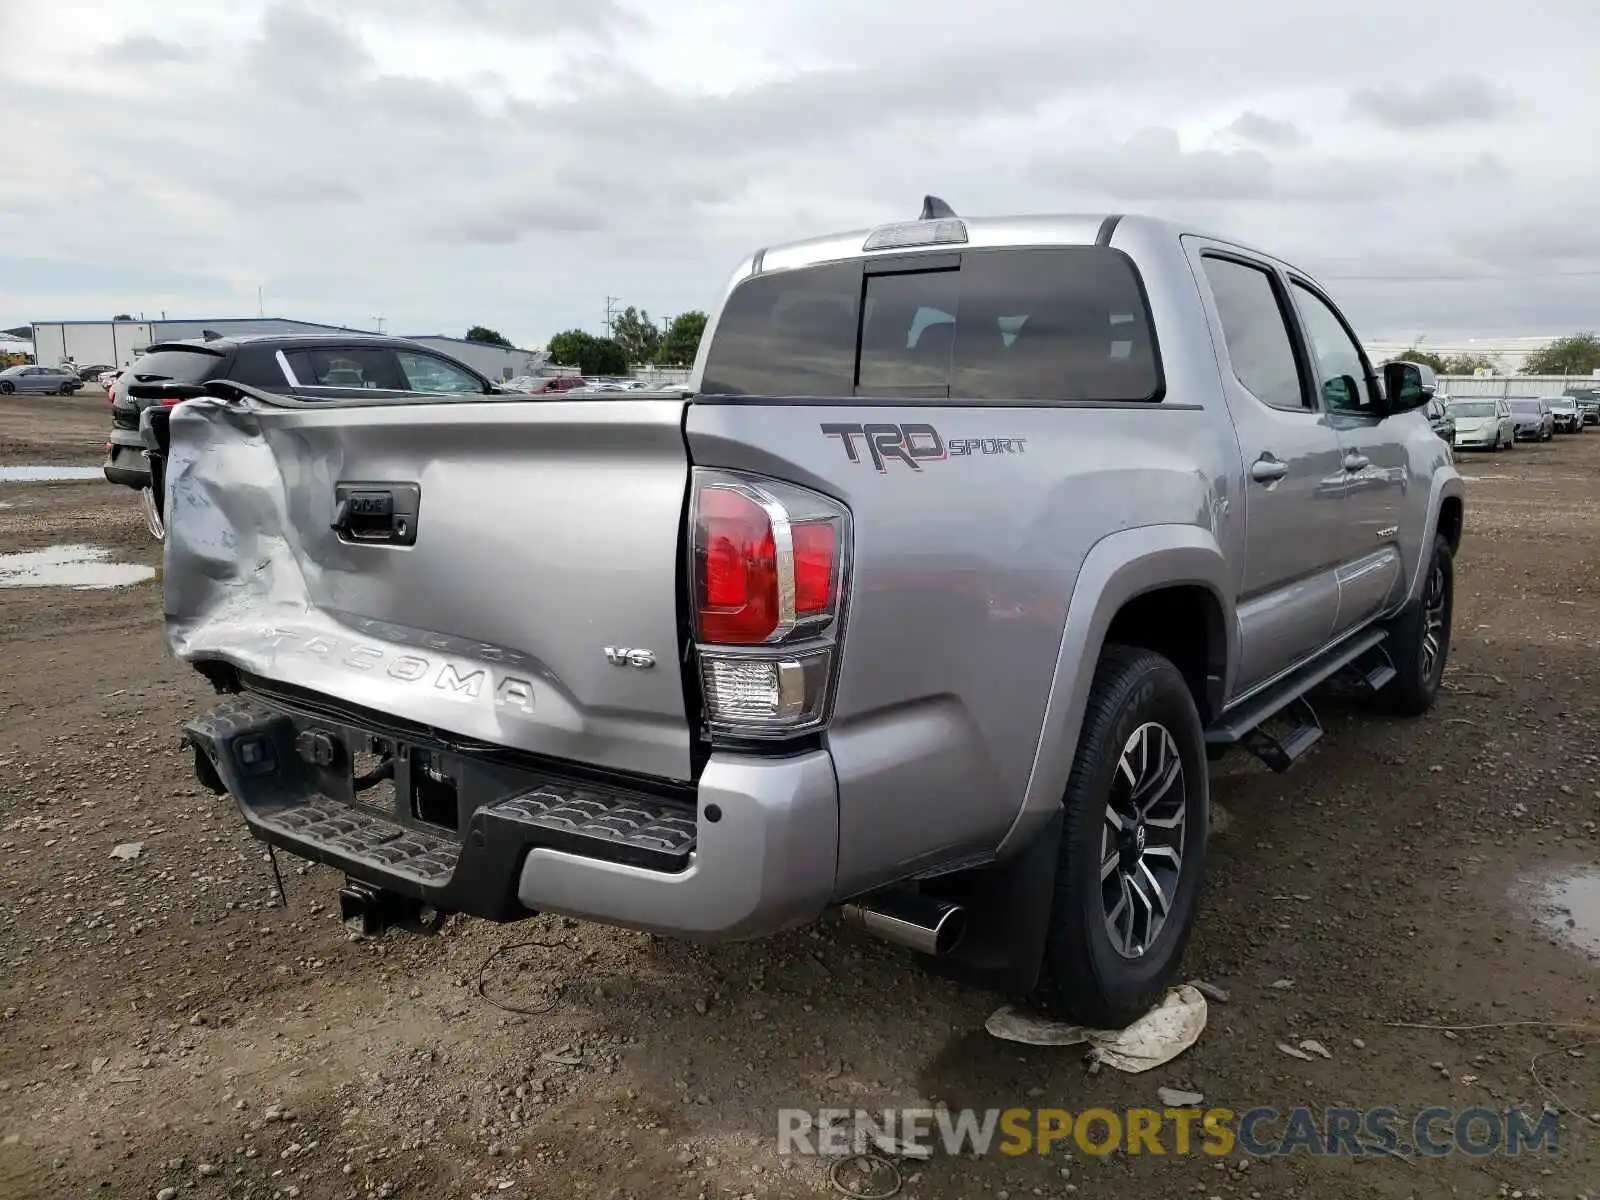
1040, 646, 1210, 1029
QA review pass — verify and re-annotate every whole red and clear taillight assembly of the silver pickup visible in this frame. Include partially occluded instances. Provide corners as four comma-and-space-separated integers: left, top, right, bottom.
690, 469, 850, 738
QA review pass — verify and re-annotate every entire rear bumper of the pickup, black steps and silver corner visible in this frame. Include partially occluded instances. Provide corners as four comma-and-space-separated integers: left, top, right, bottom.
186, 694, 838, 941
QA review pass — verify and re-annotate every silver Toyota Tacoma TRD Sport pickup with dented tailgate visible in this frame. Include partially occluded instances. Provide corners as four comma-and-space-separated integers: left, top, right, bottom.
163, 197, 1462, 1026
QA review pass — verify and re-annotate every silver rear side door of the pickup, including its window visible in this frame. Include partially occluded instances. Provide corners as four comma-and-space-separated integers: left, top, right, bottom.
1186, 238, 1346, 696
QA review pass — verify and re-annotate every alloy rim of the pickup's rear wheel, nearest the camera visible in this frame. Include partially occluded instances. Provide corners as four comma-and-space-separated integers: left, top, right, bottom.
1099, 722, 1189, 958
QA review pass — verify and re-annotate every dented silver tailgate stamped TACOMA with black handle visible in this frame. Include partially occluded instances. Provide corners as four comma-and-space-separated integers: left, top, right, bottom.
165, 397, 690, 779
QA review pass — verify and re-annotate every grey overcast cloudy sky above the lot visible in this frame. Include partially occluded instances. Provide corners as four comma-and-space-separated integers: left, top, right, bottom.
0, 0, 1600, 356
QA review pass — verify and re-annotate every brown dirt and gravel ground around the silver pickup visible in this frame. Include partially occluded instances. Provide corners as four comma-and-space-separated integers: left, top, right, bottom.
0, 395, 1600, 1200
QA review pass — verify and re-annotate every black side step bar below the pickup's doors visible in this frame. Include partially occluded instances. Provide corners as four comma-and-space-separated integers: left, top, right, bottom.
1205, 629, 1395, 771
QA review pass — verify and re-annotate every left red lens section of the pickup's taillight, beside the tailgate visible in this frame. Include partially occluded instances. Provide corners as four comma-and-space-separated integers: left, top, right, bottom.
696, 488, 778, 645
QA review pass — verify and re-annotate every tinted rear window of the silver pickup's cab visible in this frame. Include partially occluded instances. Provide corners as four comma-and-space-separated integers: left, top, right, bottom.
702, 246, 1160, 402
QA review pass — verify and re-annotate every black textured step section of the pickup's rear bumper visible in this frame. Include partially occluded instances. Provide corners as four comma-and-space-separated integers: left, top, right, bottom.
184, 696, 696, 920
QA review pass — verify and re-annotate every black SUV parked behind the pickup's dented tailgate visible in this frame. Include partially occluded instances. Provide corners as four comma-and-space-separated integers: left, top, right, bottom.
106, 334, 501, 499
